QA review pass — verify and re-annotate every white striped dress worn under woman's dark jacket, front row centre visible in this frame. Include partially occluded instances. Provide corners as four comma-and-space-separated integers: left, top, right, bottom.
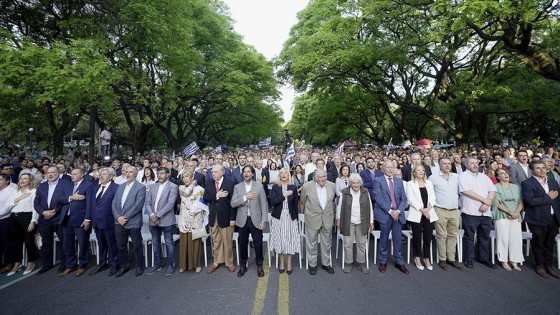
270, 187, 300, 255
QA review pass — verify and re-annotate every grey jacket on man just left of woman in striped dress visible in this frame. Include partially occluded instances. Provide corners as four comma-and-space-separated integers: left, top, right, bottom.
231, 181, 268, 227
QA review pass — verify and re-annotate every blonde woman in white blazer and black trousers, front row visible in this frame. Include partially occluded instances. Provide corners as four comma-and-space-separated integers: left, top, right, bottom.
406, 165, 438, 270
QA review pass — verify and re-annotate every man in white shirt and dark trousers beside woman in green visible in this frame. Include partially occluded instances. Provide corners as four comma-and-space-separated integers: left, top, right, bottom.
459, 157, 497, 269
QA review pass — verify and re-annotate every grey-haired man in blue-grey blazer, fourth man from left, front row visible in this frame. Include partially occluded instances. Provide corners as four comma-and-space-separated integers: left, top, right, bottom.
112, 166, 146, 277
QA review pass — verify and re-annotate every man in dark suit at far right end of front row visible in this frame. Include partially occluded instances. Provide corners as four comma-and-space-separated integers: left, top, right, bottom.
521, 161, 560, 278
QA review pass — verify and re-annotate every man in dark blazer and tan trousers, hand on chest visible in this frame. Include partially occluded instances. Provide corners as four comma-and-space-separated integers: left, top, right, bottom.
204, 165, 236, 273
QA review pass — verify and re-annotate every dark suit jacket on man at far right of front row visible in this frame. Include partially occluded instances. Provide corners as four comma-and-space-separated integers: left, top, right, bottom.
521, 177, 560, 226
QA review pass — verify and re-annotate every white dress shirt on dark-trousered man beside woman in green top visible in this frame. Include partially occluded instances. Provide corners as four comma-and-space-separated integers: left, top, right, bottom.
459, 170, 496, 217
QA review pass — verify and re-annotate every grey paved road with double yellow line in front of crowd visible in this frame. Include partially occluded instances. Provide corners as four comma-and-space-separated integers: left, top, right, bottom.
0, 242, 560, 315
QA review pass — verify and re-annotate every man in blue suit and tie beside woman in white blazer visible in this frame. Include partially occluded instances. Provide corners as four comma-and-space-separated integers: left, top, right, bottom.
373, 161, 408, 274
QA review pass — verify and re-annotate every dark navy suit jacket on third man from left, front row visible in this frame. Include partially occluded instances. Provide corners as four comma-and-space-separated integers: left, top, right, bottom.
85, 182, 119, 230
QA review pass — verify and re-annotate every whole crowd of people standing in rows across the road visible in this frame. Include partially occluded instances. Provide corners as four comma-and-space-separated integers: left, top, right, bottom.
0, 143, 560, 278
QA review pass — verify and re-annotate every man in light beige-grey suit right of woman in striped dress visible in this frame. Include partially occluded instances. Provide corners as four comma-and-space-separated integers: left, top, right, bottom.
301, 169, 336, 275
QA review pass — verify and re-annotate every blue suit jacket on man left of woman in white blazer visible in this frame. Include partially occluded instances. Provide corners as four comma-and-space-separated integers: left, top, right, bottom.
373, 176, 406, 224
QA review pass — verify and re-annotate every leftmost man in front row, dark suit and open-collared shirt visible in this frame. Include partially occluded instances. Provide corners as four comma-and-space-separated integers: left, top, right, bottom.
34, 166, 72, 274
